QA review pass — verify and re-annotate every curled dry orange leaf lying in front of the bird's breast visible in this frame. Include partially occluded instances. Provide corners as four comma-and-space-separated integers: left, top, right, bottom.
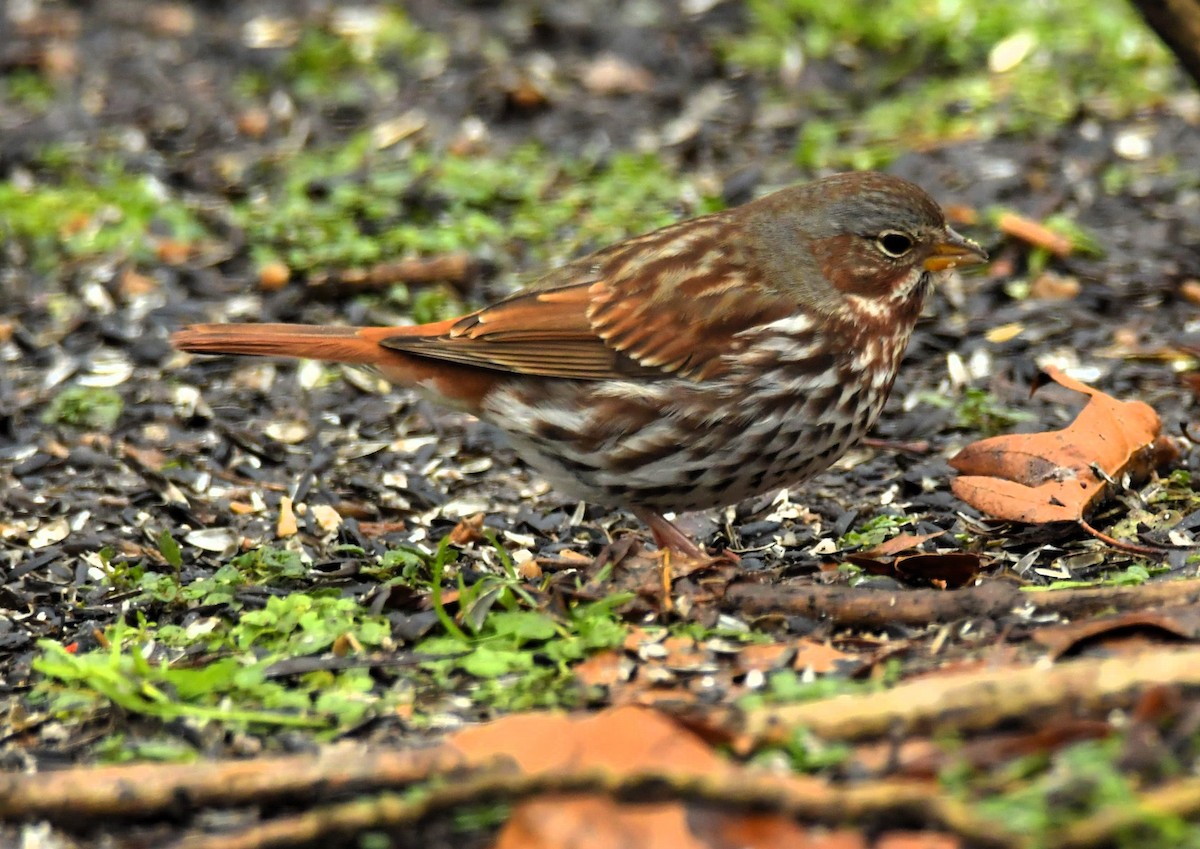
950, 368, 1162, 523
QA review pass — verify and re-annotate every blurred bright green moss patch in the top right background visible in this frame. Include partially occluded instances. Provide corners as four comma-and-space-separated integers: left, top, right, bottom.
725, 0, 1175, 168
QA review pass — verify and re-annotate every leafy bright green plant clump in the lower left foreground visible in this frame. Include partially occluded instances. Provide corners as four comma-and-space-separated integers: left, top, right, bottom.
34, 539, 408, 738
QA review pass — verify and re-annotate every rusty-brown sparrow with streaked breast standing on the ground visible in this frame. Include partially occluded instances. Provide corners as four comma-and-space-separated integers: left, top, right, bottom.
173, 173, 986, 556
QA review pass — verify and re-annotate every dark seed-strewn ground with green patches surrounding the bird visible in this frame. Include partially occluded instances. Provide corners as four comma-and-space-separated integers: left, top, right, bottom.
0, 0, 1200, 845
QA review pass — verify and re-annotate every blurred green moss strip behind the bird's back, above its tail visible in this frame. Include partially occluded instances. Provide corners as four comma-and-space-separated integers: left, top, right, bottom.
234, 133, 713, 280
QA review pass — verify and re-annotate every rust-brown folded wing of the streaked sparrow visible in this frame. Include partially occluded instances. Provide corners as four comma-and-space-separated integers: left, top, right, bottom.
380, 213, 790, 380
